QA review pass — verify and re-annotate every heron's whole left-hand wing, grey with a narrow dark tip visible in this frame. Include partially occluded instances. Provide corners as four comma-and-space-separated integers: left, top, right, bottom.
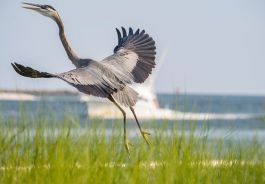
12, 63, 125, 97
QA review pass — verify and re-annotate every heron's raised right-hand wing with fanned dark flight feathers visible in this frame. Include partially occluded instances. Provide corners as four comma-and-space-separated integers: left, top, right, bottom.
102, 27, 156, 83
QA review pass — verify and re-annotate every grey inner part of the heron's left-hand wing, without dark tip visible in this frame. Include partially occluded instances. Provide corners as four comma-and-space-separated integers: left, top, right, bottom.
58, 66, 124, 97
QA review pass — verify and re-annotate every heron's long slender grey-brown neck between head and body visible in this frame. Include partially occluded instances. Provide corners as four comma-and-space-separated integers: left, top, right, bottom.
55, 16, 79, 67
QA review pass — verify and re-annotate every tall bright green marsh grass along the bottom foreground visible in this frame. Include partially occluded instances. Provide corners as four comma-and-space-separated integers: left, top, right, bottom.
0, 115, 265, 184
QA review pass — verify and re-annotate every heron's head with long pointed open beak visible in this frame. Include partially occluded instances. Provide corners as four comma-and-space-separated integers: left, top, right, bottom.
22, 3, 59, 19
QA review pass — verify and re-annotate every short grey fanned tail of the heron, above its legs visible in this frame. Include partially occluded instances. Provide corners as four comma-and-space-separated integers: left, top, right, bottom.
112, 86, 138, 107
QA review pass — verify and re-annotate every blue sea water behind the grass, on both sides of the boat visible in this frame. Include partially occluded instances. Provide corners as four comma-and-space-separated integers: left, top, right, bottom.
0, 94, 265, 140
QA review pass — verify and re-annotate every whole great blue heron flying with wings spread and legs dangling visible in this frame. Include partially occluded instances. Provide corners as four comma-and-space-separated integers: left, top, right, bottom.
11, 3, 156, 152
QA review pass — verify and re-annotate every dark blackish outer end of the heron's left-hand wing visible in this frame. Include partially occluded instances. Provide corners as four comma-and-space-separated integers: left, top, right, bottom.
11, 63, 56, 78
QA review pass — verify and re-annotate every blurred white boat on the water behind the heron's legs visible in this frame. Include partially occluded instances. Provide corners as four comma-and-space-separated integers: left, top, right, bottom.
80, 79, 175, 119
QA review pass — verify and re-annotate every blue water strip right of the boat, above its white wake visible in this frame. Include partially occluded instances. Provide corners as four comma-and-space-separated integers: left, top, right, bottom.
158, 94, 265, 114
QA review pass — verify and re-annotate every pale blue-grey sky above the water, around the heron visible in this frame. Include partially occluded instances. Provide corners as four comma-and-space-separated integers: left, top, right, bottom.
0, 0, 265, 95
